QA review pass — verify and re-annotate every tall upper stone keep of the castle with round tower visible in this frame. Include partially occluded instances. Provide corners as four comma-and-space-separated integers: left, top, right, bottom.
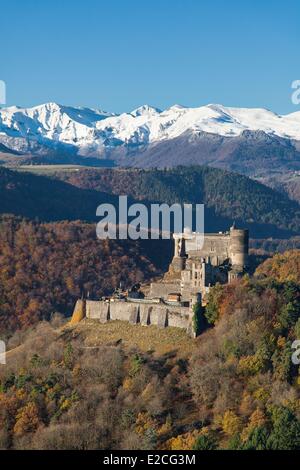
151, 225, 249, 301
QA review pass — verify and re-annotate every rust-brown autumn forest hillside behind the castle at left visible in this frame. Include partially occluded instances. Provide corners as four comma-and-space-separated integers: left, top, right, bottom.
0, 216, 172, 333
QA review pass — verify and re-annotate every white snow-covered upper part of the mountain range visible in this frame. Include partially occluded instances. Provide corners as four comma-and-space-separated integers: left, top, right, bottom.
0, 103, 300, 155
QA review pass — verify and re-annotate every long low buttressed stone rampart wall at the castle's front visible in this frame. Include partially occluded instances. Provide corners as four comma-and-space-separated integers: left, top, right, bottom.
85, 300, 193, 330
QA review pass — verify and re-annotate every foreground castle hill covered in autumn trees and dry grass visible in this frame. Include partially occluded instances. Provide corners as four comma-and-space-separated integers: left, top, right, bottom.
0, 251, 300, 450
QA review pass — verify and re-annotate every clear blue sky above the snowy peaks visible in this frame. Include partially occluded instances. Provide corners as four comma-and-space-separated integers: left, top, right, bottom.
0, 0, 300, 113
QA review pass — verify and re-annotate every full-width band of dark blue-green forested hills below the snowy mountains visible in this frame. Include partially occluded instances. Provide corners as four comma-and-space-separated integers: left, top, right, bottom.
0, 167, 300, 238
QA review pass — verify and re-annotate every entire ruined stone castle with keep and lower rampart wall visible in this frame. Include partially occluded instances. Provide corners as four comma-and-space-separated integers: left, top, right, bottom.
71, 225, 249, 333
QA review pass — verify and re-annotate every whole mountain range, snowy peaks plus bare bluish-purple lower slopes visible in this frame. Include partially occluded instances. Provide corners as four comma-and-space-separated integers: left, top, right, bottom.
0, 103, 300, 175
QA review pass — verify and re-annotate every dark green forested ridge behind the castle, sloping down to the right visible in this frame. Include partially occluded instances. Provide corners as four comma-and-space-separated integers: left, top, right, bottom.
55, 166, 300, 237
